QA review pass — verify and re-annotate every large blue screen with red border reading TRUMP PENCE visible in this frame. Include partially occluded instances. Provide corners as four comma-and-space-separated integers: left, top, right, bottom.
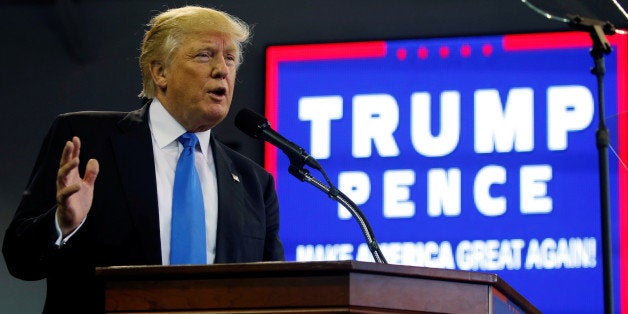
265, 32, 628, 313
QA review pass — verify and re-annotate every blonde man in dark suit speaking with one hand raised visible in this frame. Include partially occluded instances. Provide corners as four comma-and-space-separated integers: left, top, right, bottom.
3, 7, 284, 313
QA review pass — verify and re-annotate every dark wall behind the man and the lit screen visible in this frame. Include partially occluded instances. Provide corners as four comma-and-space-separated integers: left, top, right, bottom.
0, 0, 628, 313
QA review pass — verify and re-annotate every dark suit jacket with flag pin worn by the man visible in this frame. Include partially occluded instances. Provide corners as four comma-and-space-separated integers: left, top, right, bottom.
3, 105, 284, 313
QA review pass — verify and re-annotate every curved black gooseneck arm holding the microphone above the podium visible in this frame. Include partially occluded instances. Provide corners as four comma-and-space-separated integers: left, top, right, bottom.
288, 163, 388, 264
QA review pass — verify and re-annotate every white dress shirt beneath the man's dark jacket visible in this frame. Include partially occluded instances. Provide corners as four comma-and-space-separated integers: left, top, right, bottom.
148, 99, 218, 265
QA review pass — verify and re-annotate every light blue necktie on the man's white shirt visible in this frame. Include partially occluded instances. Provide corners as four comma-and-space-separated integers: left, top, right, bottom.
170, 132, 207, 265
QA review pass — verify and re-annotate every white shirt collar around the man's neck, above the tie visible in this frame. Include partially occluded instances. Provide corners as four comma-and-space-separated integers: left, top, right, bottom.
148, 98, 211, 156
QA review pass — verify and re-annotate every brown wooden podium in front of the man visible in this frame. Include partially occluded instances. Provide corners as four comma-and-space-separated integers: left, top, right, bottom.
96, 261, 540, 313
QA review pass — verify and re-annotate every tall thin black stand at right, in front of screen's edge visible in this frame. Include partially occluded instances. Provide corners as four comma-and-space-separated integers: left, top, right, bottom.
567, 15, 615, 314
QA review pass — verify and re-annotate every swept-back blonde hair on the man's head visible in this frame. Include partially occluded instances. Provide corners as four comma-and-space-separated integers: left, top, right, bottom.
139, 6, 251, 98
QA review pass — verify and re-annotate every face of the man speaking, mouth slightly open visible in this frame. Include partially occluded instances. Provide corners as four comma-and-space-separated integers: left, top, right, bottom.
157, 33, 239, 132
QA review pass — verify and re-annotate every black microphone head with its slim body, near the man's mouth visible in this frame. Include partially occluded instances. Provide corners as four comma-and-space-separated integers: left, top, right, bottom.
235, 108, 321, 170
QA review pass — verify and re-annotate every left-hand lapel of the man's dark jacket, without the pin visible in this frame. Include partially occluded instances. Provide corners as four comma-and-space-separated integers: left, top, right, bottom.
112, 105, 161, 264
